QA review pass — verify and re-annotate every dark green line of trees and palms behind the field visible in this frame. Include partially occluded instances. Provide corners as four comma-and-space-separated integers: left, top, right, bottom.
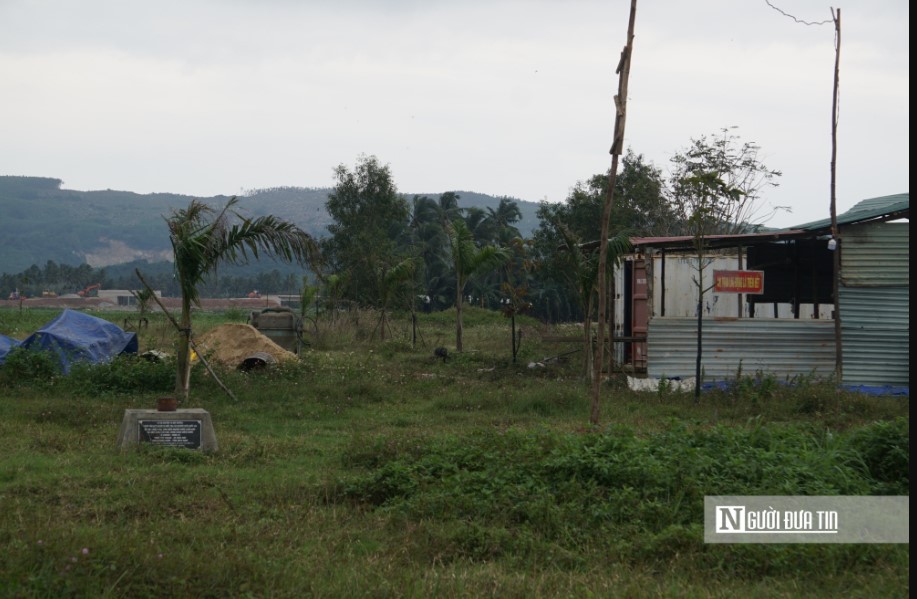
0, 129, 780, 332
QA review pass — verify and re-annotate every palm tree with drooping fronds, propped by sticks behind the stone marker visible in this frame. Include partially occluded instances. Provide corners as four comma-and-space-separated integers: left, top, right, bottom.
166, 197, 317, 401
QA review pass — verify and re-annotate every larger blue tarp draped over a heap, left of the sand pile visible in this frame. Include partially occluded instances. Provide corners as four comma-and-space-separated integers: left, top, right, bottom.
22, 310, 138, 374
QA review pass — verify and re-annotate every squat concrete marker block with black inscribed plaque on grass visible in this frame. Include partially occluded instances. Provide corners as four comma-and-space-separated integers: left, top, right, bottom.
118, 408, 217, 451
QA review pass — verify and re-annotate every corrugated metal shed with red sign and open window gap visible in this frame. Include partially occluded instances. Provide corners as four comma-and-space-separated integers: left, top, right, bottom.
633, 193, 910, 385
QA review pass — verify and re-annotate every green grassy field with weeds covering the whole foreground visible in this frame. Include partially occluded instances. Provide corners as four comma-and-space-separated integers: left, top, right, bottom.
0, 309, 910, 598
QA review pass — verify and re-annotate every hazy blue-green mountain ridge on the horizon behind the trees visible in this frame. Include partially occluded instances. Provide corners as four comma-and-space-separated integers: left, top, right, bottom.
0, 176, 538, 274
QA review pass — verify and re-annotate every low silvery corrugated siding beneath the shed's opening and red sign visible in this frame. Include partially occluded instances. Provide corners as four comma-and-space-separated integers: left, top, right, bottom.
647, 318, 835, 381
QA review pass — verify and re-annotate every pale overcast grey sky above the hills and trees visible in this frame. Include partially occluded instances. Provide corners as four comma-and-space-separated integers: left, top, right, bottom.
0, 0, 910, 227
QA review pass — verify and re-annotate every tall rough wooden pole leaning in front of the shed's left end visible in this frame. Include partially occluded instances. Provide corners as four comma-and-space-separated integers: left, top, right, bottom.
589, 0, 637, 425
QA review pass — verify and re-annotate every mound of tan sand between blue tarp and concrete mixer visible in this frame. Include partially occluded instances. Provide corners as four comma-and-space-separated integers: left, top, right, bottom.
194, 324, 296, 369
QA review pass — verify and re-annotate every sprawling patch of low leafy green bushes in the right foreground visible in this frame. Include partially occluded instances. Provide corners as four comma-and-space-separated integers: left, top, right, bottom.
341, 421, 908, 559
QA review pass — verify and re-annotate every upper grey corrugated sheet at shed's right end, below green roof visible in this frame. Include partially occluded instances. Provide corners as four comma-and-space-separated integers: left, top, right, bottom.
841, 222, 910, 288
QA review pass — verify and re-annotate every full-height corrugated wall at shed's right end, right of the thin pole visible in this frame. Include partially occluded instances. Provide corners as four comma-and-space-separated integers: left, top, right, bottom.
840, 223, 910, 386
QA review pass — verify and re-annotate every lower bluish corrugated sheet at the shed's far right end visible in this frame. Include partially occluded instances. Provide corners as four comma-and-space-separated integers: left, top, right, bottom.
840, 287, 910, 385
